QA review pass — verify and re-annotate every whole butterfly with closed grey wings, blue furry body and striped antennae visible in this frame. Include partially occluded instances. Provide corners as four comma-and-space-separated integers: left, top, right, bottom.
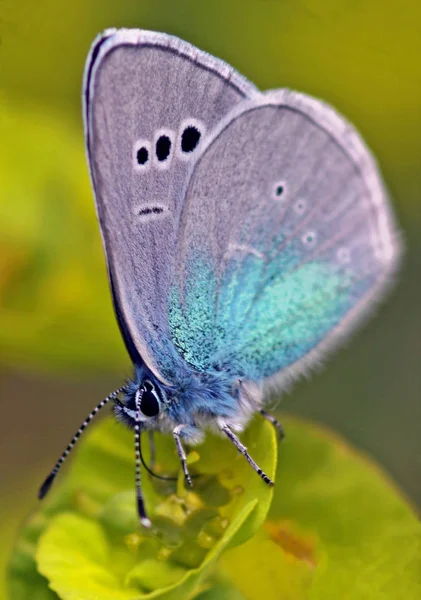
39, 29, 399, 527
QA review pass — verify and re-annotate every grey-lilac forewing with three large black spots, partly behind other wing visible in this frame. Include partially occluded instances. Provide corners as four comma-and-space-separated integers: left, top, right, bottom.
84, 30, 260, 382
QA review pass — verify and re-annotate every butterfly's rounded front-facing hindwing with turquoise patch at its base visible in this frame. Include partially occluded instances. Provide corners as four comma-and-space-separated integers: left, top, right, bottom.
169, 90, 399, 384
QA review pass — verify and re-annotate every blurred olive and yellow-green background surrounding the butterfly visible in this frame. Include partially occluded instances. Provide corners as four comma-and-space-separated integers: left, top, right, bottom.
0, 0, 421, 580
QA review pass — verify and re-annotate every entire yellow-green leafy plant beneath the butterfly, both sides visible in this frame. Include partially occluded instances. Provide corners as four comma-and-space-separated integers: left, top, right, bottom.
10, 418, 421, 600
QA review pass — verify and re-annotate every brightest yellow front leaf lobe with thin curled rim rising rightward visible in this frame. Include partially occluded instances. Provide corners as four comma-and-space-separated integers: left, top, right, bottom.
37, 502, 255, 600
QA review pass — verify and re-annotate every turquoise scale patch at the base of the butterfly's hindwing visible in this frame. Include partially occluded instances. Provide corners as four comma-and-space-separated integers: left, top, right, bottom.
170, 256, 368, 381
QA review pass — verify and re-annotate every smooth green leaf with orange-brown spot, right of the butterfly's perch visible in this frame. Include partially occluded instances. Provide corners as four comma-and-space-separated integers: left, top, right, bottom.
220, 418, 421, 600
